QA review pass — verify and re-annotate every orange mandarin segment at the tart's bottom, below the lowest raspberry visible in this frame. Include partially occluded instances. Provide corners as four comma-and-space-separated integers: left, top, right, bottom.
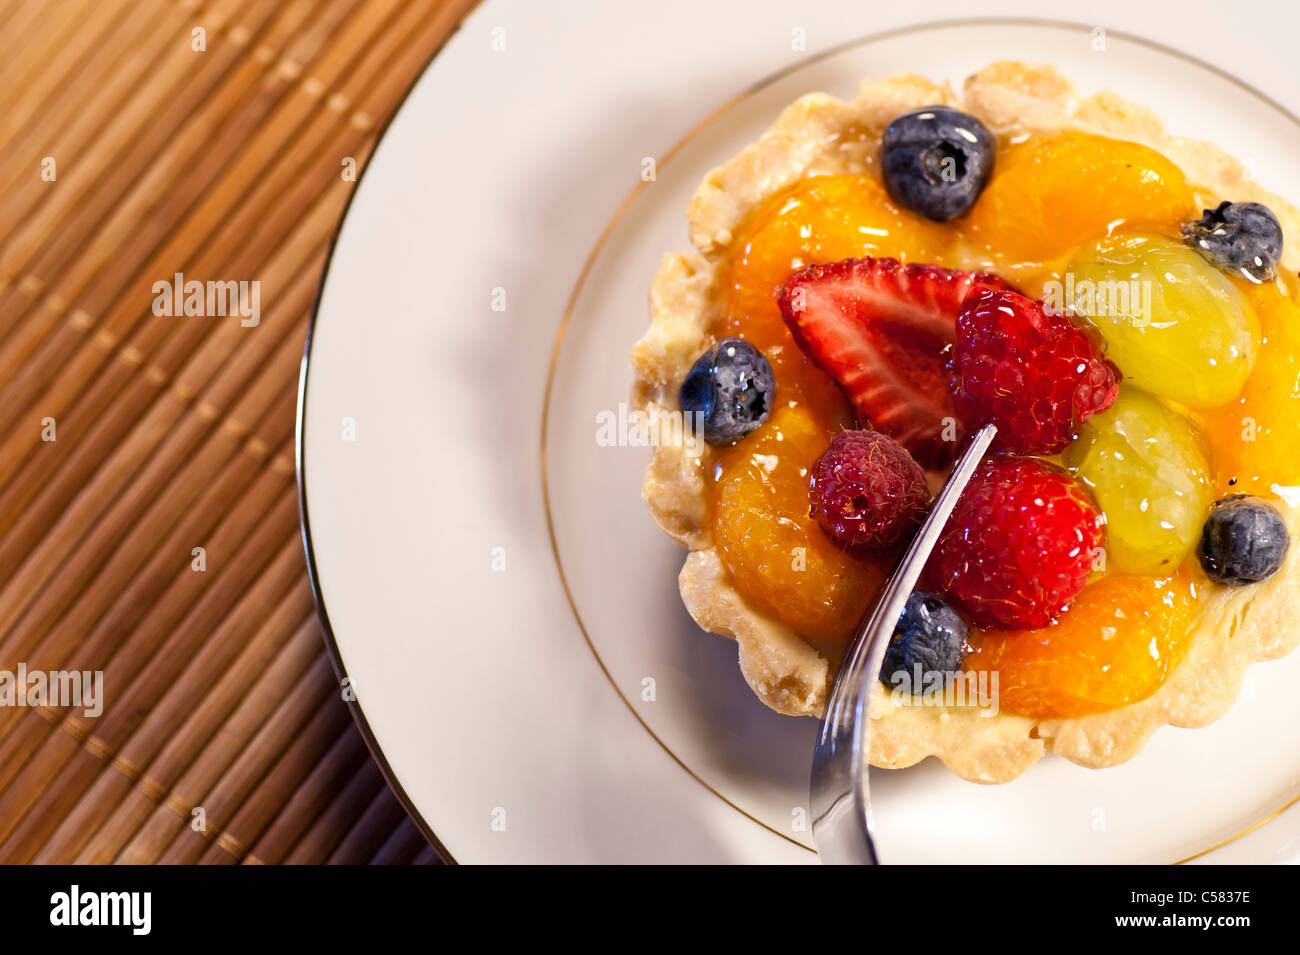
965, 572, 1197, 720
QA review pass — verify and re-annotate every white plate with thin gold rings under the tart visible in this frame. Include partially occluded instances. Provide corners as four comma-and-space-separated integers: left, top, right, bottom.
299, 1, 1300, 861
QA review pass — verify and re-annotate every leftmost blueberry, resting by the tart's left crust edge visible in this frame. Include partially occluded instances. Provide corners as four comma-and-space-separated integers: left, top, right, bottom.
680, 338, 776, 444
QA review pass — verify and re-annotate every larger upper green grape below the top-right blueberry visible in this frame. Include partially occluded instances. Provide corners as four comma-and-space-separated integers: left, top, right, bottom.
1066, 235, 1260, 408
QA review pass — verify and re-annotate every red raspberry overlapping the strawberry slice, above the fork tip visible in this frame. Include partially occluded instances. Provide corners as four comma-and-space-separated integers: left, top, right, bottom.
953, 286, 1119, 455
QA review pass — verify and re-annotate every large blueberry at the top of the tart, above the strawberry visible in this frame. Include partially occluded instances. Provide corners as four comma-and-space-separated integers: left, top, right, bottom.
881, 107, 996, 222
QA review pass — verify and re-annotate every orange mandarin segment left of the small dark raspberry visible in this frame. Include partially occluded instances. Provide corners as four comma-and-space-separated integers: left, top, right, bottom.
714, 405, 885, 643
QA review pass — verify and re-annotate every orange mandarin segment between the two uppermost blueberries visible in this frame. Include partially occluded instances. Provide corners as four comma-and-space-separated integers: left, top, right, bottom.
963, 133, 1197, 266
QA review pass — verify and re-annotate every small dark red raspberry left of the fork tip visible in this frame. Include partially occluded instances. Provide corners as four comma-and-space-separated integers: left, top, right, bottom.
809, 431, 930, 550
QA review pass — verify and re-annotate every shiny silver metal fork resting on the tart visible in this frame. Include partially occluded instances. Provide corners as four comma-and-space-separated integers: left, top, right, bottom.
810, 425, 997, 865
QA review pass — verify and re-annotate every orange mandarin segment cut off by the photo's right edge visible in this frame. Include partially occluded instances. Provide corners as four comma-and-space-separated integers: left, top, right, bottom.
1203, 282, 1300, 496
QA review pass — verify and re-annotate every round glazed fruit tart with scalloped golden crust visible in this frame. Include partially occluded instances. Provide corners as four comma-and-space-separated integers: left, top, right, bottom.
632, 62, 1300, 782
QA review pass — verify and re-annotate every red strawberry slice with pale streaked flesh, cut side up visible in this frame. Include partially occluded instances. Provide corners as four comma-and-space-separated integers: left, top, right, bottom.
777, 257, 1010, 468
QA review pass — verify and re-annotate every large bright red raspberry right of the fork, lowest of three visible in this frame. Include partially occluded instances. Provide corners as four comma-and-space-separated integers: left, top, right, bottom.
927, 457, 1102, 629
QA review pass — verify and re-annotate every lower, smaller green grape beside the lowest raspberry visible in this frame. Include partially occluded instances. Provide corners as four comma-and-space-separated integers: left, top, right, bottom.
1066, 385, 1212, 576
